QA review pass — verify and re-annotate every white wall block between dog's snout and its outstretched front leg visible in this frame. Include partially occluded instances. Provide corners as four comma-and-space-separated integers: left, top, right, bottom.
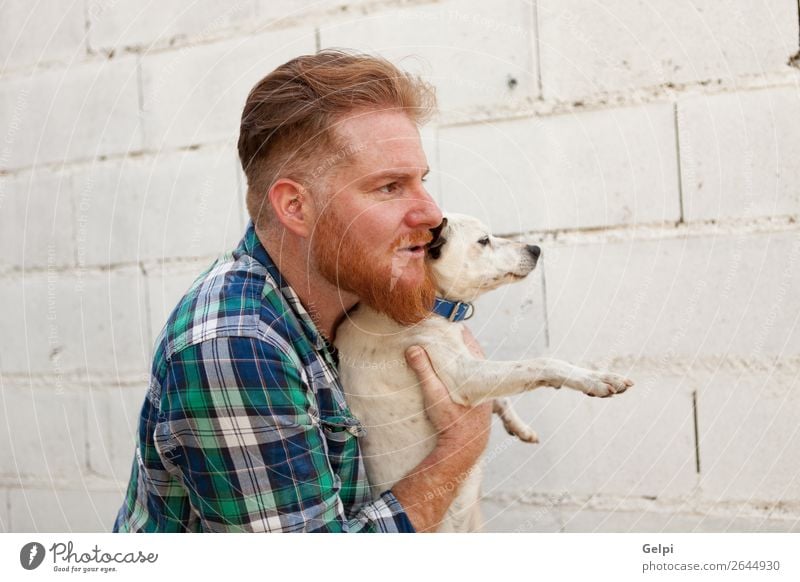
468, 269, 547, 360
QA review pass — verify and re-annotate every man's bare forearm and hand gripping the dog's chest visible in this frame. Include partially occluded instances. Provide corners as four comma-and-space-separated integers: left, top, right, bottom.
392, 328, 492, 531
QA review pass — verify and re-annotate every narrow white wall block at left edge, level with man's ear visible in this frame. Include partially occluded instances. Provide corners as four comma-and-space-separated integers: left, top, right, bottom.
0, 169, 75, 267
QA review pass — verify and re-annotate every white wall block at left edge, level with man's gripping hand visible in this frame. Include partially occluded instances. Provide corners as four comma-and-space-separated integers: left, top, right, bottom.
0, 382, 86, 479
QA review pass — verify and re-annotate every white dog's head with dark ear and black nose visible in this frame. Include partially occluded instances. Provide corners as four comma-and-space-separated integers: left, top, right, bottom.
427, 214, 541, 301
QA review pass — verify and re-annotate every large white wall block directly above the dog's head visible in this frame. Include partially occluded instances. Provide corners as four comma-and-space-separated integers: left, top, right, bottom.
439, 103, 680, 233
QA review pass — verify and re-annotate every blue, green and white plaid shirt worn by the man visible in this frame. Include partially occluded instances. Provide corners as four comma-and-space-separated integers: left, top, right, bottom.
114, 223, 414, 532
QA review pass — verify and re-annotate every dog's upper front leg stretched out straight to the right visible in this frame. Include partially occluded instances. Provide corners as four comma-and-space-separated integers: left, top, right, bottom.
428, 349, 633, 406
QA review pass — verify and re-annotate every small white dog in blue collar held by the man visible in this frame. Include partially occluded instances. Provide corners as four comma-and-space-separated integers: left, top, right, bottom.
336, 214, 633, 531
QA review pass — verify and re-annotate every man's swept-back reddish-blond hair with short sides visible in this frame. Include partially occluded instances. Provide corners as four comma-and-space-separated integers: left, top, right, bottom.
239, 50, 436, 225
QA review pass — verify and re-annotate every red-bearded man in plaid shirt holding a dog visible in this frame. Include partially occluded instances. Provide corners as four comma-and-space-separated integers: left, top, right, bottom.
114, 51, 490, 532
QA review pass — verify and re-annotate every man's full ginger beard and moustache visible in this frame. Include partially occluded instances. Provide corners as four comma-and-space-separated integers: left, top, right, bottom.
311, 208, 436, 325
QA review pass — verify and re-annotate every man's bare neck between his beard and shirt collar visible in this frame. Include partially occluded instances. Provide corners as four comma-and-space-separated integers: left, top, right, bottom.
256, 230, 358, 342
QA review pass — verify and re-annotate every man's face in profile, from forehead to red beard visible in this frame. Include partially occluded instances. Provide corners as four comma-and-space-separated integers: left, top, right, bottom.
311, 110, 442, 324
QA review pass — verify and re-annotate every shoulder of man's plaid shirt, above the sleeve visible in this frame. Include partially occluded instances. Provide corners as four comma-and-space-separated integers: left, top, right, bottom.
156, 253, 284, 361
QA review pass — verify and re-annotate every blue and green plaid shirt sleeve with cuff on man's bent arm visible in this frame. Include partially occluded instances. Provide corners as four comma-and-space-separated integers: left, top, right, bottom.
155, 337, 414, 532
